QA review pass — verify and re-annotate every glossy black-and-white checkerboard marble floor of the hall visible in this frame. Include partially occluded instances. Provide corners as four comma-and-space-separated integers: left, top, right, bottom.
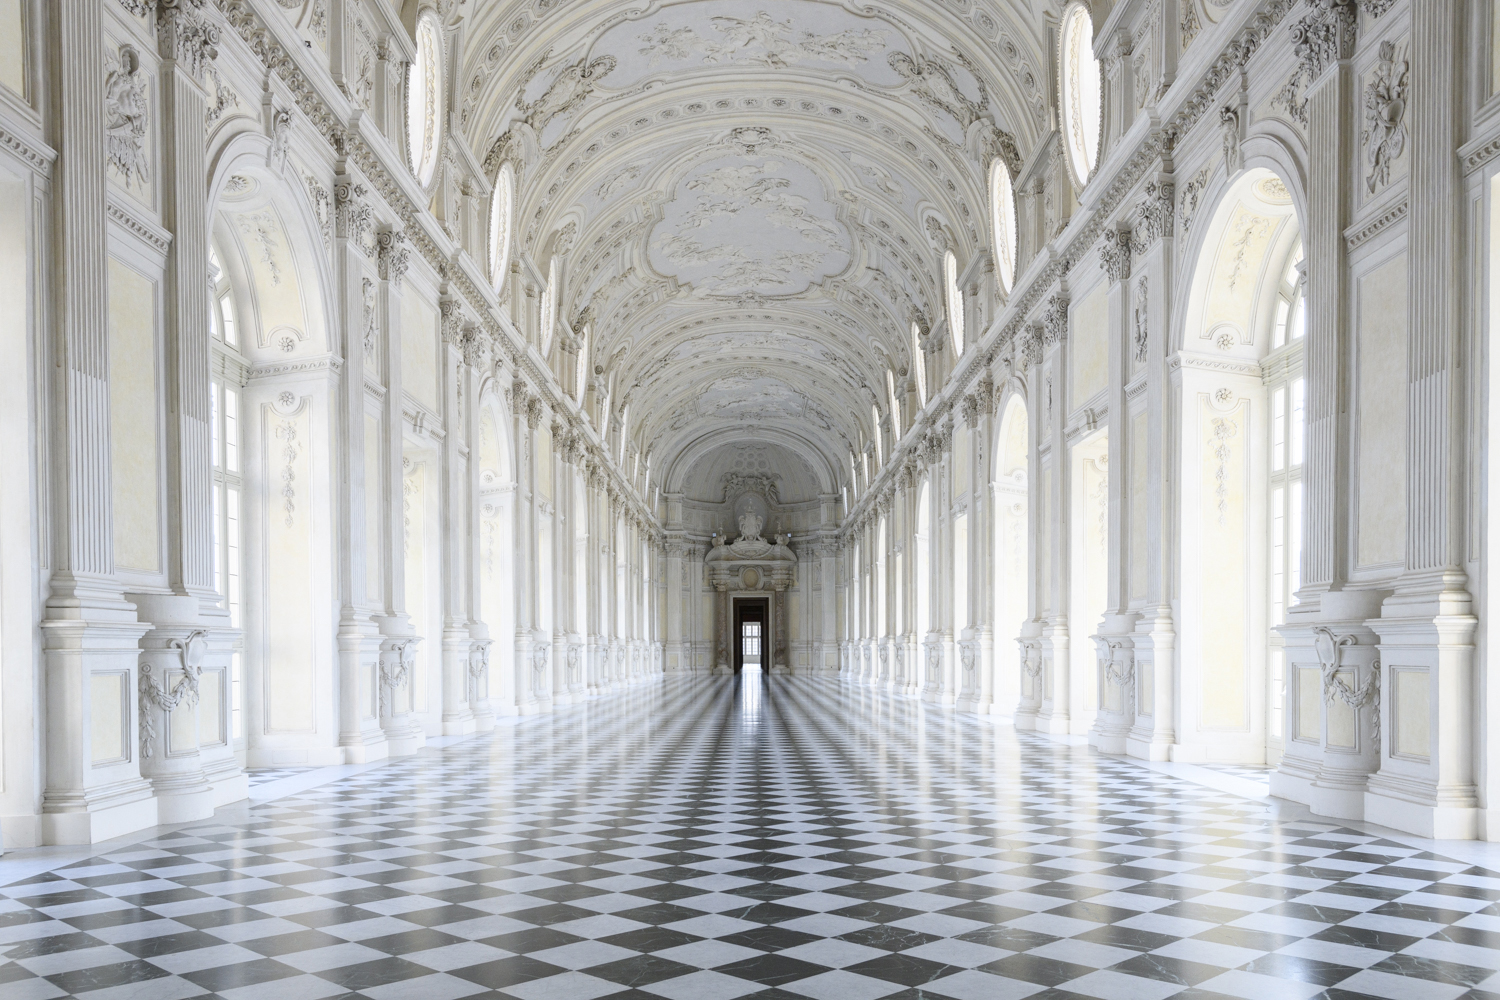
0, 676, 1500, 1000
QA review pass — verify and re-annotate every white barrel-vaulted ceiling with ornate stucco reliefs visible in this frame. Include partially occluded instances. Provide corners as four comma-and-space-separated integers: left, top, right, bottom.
459, 0, 1049, 489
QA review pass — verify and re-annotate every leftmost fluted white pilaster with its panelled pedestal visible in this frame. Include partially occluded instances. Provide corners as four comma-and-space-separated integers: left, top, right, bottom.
41, 0, 158, 844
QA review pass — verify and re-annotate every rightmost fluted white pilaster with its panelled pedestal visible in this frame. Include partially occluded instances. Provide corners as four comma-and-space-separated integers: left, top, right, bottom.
1364, 4, 1476, 838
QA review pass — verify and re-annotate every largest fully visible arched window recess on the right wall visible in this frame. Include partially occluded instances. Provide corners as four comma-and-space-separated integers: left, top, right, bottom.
1178, 168, 1305, 763
